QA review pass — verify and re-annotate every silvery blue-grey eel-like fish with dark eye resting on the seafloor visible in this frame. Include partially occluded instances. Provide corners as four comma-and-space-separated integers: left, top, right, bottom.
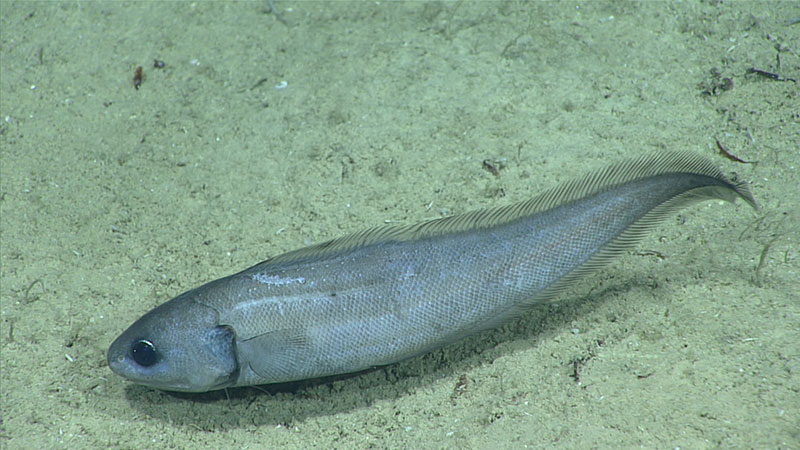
107, 151, 758, 392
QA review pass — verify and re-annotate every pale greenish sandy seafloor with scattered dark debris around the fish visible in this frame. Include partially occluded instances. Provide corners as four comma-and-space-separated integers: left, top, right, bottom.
0, 1, 800, 449
